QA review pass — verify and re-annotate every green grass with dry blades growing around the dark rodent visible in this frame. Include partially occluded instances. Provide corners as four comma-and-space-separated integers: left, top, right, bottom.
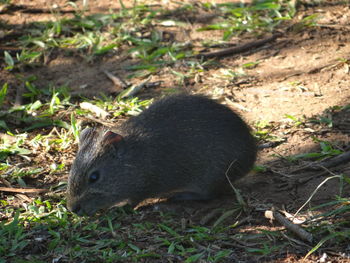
0, 0, 350, 263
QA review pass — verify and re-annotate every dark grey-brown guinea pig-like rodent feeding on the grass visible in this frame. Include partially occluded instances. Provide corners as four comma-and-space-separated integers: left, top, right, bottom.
67, 95, 256, 215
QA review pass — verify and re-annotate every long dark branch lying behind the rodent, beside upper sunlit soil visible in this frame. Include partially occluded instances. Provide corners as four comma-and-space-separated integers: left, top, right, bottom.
193, 34, 281, 58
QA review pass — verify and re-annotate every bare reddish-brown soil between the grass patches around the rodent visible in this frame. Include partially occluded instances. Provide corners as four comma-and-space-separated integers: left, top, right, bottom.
0, 0, 350, 262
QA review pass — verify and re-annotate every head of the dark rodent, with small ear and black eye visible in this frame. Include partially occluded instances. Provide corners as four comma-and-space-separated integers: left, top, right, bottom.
67, 128, 128, 215
